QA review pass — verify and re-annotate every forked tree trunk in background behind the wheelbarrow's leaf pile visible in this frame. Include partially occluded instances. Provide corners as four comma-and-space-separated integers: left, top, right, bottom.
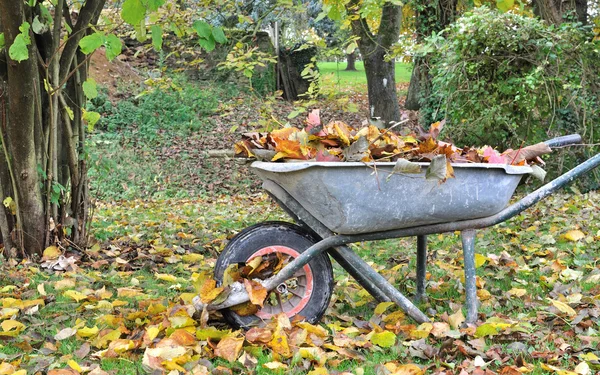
346, 0, 402, 127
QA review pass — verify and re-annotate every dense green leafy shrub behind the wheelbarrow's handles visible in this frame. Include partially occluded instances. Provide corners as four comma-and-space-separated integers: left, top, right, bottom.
422, 7, 600, 189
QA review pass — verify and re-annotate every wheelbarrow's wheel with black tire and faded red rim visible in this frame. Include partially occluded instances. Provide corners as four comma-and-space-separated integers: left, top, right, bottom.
215, 222, 333, 329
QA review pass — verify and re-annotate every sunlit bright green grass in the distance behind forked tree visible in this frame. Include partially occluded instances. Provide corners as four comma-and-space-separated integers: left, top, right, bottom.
317, 61, 412, 93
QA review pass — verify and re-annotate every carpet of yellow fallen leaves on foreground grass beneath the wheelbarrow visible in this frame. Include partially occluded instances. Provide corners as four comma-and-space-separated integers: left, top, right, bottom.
0, 180, 600, 375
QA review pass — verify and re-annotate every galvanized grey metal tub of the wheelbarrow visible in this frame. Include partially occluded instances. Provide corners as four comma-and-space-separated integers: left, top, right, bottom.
252, 162, 531, 234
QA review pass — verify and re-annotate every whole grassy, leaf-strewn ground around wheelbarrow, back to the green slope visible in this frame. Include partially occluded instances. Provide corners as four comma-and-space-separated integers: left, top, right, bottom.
0, 74, 600, 375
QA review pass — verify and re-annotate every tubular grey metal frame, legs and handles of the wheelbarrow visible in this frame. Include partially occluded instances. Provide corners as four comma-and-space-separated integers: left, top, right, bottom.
193, 136, 600, 323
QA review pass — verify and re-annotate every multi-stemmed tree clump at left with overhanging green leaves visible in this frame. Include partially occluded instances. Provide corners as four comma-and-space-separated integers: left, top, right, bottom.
0, 0, 227, 256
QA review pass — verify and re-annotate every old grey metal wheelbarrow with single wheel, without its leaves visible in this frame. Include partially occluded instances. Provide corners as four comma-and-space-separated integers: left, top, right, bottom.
194, 134, 600, 329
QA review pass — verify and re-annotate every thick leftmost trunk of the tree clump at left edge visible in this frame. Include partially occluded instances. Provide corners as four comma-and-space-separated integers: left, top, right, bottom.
0, 0, 45, 254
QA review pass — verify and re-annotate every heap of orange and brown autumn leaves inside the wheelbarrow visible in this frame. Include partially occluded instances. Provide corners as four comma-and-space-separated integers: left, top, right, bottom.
234, 109, 551, 180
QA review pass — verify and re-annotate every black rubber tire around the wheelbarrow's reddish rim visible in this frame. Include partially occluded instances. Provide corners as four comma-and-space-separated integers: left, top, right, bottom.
215, 221, 334, 329
